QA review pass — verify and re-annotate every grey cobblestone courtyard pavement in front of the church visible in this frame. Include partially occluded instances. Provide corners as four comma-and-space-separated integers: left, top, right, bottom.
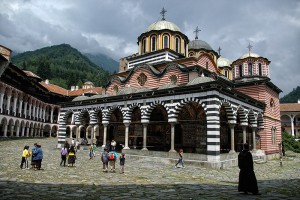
0, 138, 300, 200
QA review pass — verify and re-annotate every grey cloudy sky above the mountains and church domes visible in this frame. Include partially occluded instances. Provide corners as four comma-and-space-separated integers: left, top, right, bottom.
0, 0, 300, 96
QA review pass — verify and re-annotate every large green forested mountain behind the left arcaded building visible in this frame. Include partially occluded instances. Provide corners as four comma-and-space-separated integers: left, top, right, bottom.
12, 44, 109, 89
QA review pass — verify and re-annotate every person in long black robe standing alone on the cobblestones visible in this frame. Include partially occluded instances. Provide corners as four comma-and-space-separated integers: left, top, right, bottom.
238, 143, 259, 195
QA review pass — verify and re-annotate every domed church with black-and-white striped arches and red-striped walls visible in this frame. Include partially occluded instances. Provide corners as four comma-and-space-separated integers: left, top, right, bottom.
58, 10, 281, 168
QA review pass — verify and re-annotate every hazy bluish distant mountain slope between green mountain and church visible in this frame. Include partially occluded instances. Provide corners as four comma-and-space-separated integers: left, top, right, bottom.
84, 53, 119, 73
